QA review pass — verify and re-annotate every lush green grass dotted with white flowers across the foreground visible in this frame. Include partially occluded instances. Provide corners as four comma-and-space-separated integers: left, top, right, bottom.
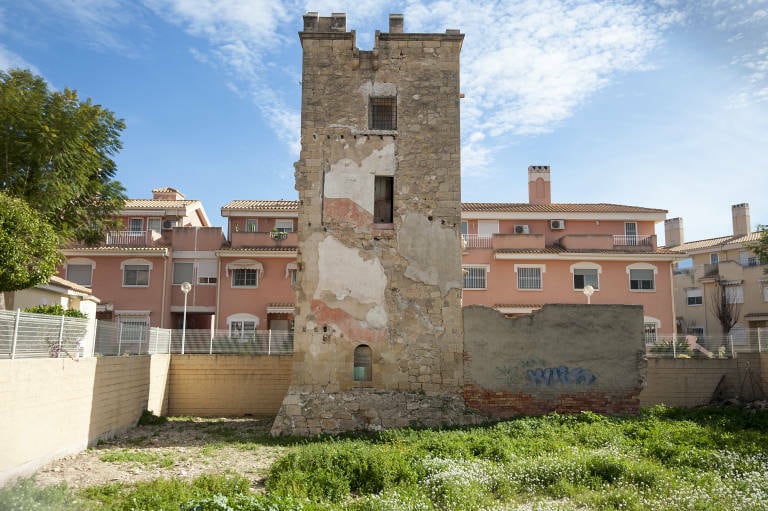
9, 407, 768, 511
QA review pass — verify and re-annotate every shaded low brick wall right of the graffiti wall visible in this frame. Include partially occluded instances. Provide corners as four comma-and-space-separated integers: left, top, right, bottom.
640, 353, 768, 407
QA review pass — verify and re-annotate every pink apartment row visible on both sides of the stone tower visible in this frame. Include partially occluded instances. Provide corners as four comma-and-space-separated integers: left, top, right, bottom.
61, 170, 680, 346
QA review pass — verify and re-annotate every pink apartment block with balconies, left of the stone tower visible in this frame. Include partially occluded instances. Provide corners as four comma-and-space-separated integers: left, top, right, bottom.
60, 188, 297, 341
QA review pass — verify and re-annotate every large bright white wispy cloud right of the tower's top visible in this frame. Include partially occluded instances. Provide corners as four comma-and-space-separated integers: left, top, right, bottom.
406, 0, 681, 172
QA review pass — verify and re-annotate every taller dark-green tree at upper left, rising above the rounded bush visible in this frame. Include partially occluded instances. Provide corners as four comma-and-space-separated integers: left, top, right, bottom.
0, 70, 125, 244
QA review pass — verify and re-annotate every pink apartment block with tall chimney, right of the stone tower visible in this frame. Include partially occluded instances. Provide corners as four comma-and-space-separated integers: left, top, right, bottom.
461, 166, 676, 339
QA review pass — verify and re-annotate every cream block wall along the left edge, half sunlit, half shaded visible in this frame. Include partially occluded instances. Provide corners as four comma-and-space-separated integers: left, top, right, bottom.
0, 357, 151, 484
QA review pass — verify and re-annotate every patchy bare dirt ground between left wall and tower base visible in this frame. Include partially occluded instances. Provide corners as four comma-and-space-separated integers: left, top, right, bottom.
35, 417, 288, 490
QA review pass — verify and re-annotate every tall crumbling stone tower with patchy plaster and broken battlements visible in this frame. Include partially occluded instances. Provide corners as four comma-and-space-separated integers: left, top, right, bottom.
272, 13, 464, 434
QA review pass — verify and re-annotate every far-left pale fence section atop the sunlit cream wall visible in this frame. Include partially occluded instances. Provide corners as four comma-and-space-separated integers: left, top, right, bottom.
0, 310, 94, 359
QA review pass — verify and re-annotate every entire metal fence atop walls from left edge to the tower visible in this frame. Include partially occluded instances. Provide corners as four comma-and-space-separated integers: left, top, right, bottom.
0, 311, 293, 359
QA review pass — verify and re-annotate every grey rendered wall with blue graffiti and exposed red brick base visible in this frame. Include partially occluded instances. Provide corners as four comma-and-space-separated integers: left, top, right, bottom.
464, 305, 646, 418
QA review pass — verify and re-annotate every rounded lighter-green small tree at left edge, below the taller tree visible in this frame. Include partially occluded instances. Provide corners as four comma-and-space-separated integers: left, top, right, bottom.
0, 193, 61, 309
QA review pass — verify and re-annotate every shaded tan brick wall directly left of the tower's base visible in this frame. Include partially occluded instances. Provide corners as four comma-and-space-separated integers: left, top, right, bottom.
168, 355, 293, 417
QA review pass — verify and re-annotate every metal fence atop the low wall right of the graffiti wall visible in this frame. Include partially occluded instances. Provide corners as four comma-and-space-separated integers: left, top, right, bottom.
645, 328, 768, 358
